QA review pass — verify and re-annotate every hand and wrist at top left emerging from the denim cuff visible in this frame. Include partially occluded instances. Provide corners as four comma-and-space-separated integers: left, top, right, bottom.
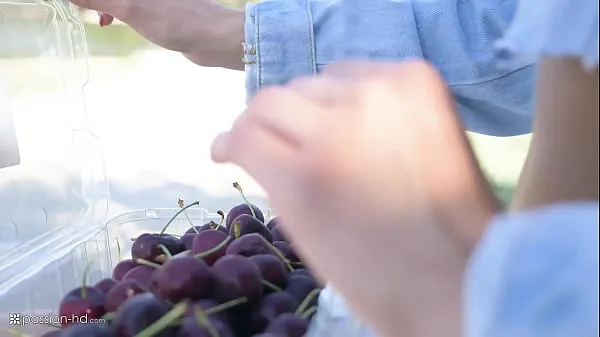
71, 0, 245, 70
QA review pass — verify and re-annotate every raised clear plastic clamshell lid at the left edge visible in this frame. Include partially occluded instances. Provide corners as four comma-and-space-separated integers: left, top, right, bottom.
0, 0, 108, 295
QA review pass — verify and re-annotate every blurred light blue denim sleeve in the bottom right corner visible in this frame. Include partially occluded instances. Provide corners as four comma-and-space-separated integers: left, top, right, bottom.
465, 203, 598, 337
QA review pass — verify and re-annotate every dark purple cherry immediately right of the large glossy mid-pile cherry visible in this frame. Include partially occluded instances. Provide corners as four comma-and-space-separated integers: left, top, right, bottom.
212, 255, 263, 302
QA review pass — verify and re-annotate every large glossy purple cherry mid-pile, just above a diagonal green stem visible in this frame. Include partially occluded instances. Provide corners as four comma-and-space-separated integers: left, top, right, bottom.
152, 255, 214, 303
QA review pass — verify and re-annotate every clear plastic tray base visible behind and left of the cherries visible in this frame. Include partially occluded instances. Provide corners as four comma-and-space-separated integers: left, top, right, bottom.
0, 207, 272, 330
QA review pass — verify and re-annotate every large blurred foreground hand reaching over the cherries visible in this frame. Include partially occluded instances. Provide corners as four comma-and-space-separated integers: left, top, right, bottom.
212, 62, 496, 337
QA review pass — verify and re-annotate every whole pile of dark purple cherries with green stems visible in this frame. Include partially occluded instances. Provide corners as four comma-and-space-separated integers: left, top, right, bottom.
45, 183, 321, 337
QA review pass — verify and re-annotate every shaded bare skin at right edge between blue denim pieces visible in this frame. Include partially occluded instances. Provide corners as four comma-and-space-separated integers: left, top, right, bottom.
511, 58, 599, 211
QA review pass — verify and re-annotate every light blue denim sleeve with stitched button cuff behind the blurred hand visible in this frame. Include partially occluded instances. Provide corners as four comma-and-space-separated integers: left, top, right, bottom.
244, 0, 535, 136
